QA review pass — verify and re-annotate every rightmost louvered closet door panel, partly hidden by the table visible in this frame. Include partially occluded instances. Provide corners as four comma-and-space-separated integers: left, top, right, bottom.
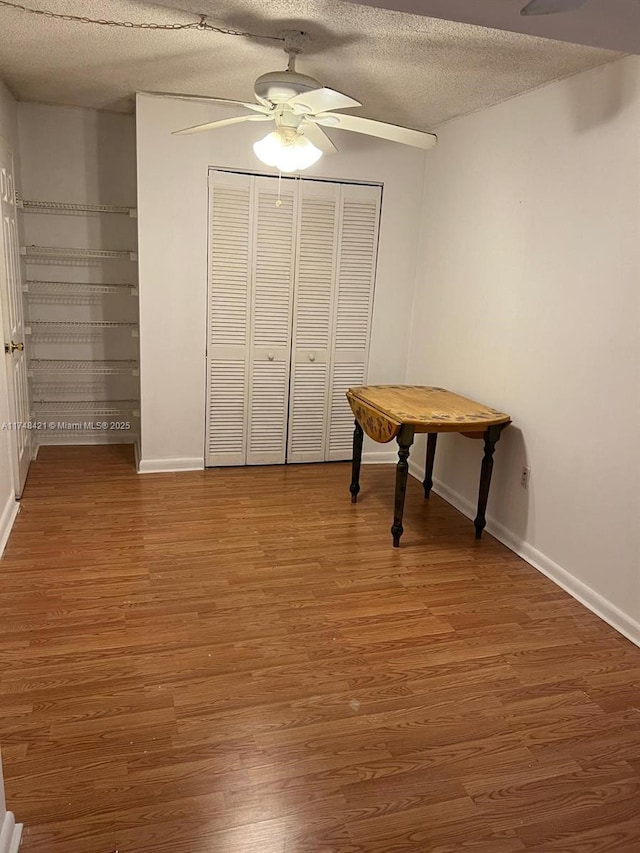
324, 184, 382, 461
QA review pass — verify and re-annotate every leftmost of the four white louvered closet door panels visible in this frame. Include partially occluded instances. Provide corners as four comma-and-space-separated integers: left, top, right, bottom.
205, 172, 253, 466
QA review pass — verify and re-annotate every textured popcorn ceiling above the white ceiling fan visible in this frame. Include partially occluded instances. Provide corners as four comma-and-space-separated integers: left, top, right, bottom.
0, 0, 617, 129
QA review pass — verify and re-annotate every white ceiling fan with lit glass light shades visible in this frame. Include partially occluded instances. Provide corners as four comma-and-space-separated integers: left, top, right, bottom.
173, 31, 437, 172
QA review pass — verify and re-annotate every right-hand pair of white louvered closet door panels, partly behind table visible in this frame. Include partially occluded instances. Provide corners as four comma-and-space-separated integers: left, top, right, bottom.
287, 179, 381, 462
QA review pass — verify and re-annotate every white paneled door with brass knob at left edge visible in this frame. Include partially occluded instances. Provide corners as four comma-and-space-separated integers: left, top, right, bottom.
0, 142, 31, 497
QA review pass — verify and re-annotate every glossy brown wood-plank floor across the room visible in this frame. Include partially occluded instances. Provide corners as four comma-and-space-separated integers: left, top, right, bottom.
0, 447, 640, 853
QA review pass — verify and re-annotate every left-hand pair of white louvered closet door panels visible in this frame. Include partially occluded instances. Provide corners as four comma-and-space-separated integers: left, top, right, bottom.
205, 171, 296, 466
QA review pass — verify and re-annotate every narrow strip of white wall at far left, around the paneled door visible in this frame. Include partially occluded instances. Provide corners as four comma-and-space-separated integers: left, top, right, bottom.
0, 80, 20, 556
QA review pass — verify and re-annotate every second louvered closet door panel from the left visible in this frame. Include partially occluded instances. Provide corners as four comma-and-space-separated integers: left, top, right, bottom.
247, 178, 297, 465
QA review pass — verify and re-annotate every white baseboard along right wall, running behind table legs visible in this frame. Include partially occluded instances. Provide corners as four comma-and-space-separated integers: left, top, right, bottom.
409, 465, 640, 646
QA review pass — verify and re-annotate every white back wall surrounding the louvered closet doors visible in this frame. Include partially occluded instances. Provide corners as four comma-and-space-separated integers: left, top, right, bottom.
137, 95, 425, 471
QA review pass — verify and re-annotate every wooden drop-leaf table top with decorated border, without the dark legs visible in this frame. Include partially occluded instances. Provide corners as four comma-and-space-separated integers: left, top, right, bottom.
347, 385, 511, 441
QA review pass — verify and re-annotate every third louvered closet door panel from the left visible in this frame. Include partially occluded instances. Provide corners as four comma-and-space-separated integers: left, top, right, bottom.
287, 180, 340, 462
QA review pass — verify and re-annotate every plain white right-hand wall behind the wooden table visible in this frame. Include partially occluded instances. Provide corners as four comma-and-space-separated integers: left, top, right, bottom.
407, 57, 640, 642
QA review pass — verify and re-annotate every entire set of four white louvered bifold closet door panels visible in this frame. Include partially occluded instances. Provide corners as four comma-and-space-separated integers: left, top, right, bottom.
205, 170, 381, 466
